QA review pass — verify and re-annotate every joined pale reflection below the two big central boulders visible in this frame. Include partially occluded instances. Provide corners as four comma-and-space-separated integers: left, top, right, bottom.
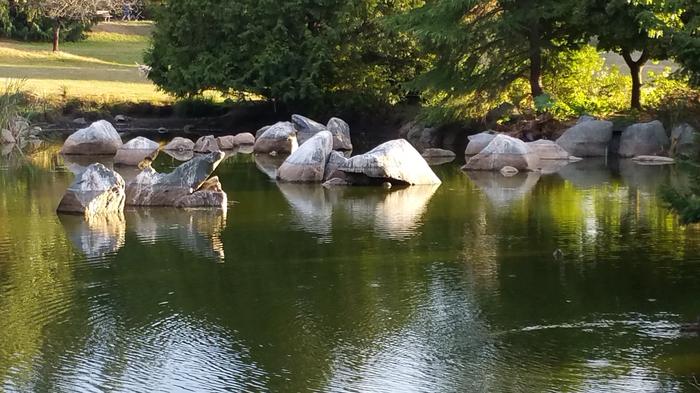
278, 183, 440, 241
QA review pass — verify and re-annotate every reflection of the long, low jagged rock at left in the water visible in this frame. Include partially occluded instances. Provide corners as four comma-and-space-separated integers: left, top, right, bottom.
125, 208, 226, 262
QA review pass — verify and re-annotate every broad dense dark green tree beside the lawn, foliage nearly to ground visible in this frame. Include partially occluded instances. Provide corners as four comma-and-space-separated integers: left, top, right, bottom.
146, 0, 422, 109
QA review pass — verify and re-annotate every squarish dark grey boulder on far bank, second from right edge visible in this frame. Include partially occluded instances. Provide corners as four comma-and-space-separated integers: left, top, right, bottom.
617, 120, 669, 157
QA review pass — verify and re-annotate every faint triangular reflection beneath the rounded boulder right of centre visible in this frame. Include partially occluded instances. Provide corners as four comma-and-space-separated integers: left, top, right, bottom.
467, 171, 540, 207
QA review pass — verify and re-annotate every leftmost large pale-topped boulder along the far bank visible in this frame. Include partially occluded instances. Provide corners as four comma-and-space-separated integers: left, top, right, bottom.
61, 120, 122, 155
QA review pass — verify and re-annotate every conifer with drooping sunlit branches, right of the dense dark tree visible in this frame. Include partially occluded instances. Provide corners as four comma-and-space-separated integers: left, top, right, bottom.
396, 0, 583, 108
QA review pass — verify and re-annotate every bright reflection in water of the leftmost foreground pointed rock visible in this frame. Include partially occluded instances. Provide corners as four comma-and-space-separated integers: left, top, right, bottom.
58, 214, 126, 258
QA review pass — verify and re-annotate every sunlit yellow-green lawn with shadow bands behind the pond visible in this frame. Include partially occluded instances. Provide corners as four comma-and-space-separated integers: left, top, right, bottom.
0, 22, 172, 103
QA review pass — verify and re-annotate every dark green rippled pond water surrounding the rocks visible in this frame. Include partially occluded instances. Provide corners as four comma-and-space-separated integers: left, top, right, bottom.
0, 148, 700, 392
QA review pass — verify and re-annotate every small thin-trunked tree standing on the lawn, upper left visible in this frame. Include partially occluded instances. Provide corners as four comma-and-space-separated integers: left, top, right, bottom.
23, 0, 126, 52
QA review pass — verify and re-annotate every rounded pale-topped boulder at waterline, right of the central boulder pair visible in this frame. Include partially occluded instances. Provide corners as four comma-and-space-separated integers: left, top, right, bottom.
463, 134, 539, 171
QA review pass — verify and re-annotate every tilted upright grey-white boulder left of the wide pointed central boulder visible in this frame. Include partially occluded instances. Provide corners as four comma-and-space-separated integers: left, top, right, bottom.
277, 131, 333, 183
